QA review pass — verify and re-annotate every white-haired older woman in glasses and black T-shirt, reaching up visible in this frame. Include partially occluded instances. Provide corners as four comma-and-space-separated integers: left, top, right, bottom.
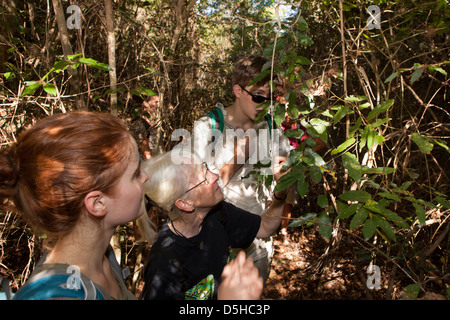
141, 152, 285, 300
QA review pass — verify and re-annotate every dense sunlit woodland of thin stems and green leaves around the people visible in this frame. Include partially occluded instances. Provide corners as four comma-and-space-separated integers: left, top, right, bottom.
0, 0, 450, 299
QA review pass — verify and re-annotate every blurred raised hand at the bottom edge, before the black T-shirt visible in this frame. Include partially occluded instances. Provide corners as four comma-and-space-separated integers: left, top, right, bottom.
217, 251, 263, 300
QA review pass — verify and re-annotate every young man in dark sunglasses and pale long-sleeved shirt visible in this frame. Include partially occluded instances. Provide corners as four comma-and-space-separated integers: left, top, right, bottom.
192, 55, 290, 281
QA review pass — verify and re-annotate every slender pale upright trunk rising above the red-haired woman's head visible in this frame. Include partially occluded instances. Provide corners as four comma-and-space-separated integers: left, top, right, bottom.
105, 0, 117, 115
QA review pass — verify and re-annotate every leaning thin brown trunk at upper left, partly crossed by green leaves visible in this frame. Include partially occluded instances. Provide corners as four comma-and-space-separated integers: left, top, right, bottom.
52, 0, 86, 110
